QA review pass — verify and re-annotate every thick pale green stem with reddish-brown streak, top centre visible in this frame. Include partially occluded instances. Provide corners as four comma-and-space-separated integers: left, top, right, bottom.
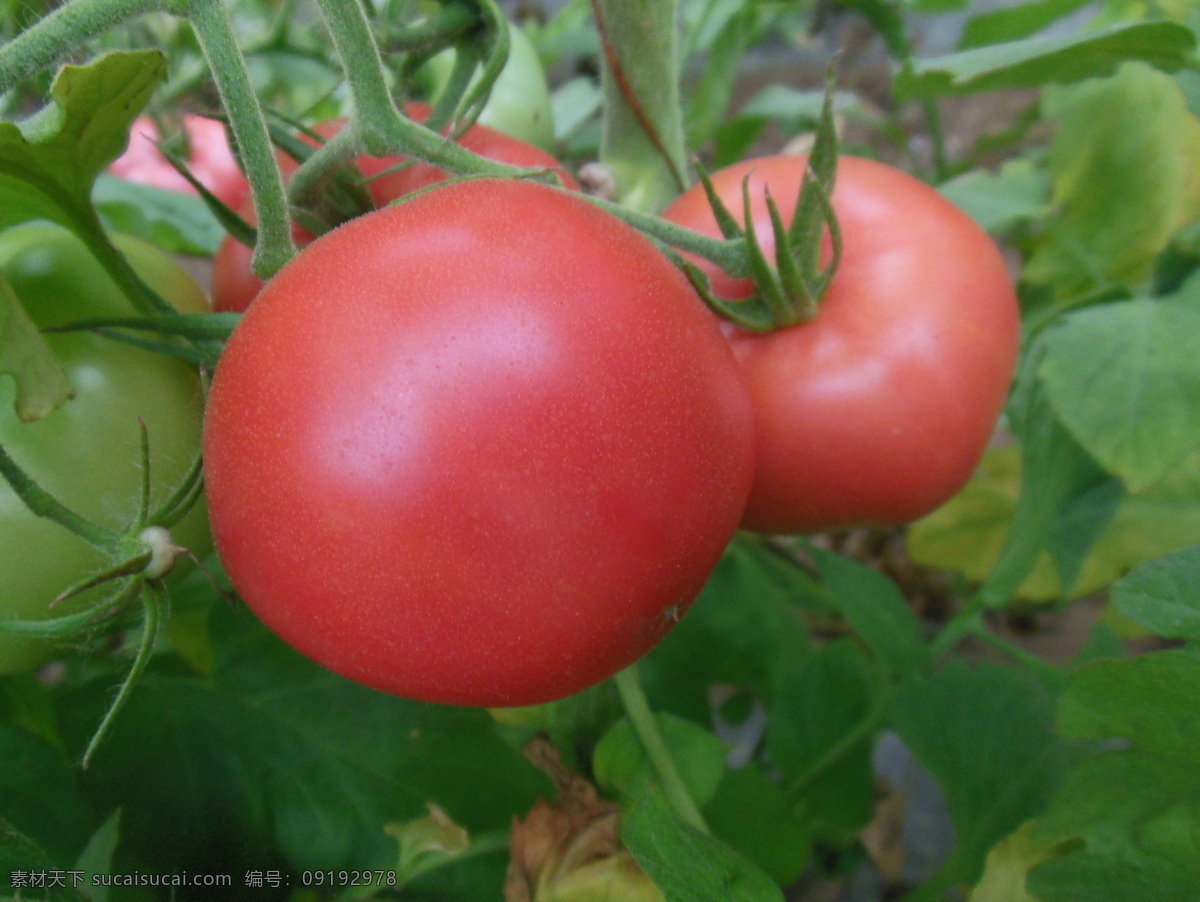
592, 0, 688, 212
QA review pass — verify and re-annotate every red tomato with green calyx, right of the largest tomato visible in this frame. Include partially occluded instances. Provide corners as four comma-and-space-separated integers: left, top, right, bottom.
662, 156, 1020, 533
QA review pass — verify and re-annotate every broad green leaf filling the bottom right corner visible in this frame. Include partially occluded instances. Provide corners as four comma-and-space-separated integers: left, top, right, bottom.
1028, 649, 1200, 902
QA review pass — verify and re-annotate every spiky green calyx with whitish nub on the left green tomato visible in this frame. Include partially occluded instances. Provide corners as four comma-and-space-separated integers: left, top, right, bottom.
0, 422, 202, 768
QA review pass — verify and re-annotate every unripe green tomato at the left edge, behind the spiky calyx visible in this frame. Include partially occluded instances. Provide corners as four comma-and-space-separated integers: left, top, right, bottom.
0, 223, 208, 673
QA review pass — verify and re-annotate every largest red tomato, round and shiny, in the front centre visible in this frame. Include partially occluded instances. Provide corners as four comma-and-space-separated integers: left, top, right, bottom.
204, 180, 754, 706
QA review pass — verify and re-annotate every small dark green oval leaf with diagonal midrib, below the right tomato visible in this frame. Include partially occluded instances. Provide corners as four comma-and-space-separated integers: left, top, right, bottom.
767, 639, 882, 840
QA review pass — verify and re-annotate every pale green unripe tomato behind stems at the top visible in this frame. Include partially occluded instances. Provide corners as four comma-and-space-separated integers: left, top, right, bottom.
416, 23, 554, 151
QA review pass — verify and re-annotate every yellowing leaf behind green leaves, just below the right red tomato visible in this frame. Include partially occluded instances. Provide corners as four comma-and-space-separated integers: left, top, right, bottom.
908, 446, 1200, 601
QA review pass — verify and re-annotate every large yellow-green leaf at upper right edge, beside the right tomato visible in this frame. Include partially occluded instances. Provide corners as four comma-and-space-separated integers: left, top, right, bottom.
1022, 65, 1200, 299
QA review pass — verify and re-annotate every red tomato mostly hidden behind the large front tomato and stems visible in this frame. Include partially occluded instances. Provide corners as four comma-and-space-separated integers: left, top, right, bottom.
212, 102, 580, 313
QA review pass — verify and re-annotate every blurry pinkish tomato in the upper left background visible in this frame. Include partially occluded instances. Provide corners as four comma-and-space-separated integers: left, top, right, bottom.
108, 113, 250, 208
